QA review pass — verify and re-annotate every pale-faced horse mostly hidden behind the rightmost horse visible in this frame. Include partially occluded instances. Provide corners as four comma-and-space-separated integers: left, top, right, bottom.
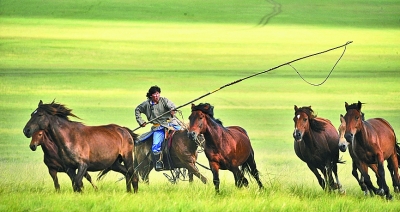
338, 114, 378, 195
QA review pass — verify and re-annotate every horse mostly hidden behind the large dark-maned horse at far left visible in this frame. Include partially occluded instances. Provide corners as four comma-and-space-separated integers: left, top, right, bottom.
29, 130, 97, 191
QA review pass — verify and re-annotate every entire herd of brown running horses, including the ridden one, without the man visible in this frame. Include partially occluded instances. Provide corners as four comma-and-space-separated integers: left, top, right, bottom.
23, 101, 400, 199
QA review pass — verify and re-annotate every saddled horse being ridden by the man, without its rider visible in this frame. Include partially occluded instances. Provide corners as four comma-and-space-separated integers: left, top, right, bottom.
134, 129, 207, 184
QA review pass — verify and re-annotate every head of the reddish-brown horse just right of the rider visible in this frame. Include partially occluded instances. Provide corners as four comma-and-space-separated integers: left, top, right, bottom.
188, 103, 214, 140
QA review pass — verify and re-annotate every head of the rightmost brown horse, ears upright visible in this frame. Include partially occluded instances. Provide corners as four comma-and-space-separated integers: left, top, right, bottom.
344, 101, 364, 143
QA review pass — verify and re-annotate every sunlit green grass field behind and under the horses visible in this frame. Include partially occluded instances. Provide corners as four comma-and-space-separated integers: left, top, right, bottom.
0, 0, 400, 211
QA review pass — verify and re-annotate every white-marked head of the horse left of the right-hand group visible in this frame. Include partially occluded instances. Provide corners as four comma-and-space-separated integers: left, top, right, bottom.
293, 105, 314, 142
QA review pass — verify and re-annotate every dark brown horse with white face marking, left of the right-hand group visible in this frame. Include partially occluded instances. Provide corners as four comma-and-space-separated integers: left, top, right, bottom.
293, 105, 342, 190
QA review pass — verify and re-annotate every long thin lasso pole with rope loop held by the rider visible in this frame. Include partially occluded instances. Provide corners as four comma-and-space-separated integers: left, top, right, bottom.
132, 41, 353, 131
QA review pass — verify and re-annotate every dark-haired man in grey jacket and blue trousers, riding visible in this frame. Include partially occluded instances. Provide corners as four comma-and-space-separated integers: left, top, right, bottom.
135, 85, 181, 171
